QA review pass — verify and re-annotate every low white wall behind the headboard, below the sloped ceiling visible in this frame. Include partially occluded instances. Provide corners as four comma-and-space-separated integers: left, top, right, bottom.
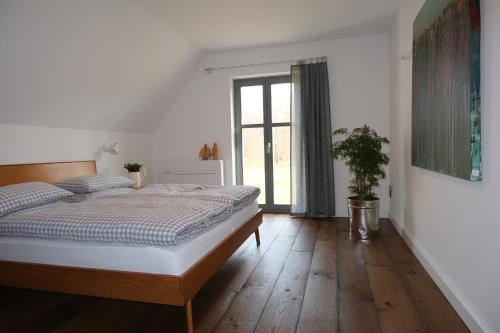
0, 124, 153, 182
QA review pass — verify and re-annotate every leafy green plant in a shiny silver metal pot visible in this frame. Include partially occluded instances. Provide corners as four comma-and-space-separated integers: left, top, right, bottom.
332, 125, 389, 239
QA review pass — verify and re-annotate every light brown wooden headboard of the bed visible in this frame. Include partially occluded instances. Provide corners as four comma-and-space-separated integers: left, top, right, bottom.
0, 161, 97, 186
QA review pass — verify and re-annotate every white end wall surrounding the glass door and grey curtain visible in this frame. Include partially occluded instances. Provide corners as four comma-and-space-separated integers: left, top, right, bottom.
154, 35, 389, 216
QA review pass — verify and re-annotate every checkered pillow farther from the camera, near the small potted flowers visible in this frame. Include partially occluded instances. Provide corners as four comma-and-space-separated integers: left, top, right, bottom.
56, 175, 134, 193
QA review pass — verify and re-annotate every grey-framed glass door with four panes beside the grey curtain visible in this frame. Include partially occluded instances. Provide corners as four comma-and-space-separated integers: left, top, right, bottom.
234, 76, 291, 212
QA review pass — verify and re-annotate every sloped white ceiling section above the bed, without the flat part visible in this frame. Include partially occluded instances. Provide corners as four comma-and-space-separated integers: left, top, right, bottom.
0, 0, 202, 133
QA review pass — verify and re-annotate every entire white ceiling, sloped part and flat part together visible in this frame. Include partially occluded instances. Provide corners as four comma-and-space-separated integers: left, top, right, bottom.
0, 0, 399, 133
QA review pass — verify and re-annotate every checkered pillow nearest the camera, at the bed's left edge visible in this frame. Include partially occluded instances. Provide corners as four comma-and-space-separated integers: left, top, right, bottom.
0, 182, 72, 216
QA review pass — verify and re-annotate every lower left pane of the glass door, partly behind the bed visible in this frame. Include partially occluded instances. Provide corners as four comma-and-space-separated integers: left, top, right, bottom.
242, 128, 266, 204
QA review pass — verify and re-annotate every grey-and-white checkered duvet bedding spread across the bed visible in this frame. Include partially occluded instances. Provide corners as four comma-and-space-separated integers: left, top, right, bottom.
0, 187, 260, 247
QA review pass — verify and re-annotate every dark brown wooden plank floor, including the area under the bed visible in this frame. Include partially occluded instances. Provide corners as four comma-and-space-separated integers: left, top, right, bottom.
0, 215, 468, 333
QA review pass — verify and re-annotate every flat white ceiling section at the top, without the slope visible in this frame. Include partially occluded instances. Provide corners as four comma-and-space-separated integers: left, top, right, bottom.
135, 0, 401, 50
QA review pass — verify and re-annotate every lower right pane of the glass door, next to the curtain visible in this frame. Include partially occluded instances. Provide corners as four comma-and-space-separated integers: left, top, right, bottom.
273, 126, 290, 205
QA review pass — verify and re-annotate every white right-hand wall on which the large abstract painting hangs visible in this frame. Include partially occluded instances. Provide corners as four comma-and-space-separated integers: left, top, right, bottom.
390, 0, 500, 332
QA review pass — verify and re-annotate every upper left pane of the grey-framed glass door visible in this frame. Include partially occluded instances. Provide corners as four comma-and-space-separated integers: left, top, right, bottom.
240, 86, 264, 125
